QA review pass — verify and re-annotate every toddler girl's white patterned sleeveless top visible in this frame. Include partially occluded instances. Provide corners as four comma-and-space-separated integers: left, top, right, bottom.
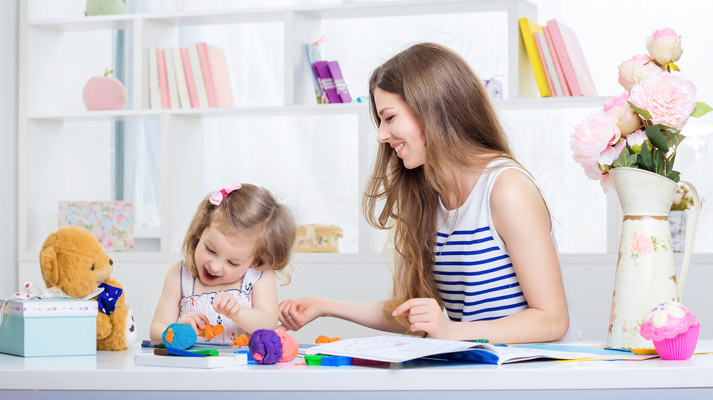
179, 262, 262, 342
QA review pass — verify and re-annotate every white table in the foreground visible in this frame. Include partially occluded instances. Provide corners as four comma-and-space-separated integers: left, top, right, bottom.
0, 341, 713, 400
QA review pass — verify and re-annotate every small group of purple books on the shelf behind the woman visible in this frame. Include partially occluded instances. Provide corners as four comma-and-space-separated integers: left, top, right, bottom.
306, 44, 352, 104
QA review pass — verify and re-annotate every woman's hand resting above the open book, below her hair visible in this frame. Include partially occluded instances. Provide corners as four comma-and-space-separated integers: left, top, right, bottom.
391, 298, 453, 339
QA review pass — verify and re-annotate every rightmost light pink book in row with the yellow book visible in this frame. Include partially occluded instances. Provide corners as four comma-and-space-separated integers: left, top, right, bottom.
547, 19, 597, 96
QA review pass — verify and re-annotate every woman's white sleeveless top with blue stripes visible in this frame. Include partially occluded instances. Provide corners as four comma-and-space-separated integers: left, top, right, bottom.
434, 160, 554, 321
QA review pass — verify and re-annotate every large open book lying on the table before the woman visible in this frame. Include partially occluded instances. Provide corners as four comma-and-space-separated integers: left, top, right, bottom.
306, 335, 656, 364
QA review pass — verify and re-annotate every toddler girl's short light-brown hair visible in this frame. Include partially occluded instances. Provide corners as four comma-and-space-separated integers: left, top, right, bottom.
182, 184, 297, 279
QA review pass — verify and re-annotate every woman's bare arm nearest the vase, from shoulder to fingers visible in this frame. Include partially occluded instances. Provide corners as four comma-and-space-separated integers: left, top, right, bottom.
394, 169, 569, 343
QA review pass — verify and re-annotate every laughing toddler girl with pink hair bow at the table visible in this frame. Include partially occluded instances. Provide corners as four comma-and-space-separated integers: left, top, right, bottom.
151, 184, 296, 342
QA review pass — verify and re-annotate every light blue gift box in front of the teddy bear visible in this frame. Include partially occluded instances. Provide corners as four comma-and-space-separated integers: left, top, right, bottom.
0, 299, 97, 357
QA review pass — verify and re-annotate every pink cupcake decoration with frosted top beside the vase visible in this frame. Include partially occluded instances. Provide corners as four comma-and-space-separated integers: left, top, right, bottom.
640, 302, 701, 360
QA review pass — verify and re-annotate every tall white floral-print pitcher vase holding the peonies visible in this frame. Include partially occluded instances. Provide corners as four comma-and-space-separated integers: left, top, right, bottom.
607, 167, 698, 349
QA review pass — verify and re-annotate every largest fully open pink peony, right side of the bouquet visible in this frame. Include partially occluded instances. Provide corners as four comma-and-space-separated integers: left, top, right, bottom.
629, 72, 696, 130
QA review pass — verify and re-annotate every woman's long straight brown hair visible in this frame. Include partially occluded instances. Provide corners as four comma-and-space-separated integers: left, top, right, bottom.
362, 43, 519, 329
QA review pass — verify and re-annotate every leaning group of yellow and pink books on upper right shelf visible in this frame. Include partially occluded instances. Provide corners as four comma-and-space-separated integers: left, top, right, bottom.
519, 18, 597, 97
